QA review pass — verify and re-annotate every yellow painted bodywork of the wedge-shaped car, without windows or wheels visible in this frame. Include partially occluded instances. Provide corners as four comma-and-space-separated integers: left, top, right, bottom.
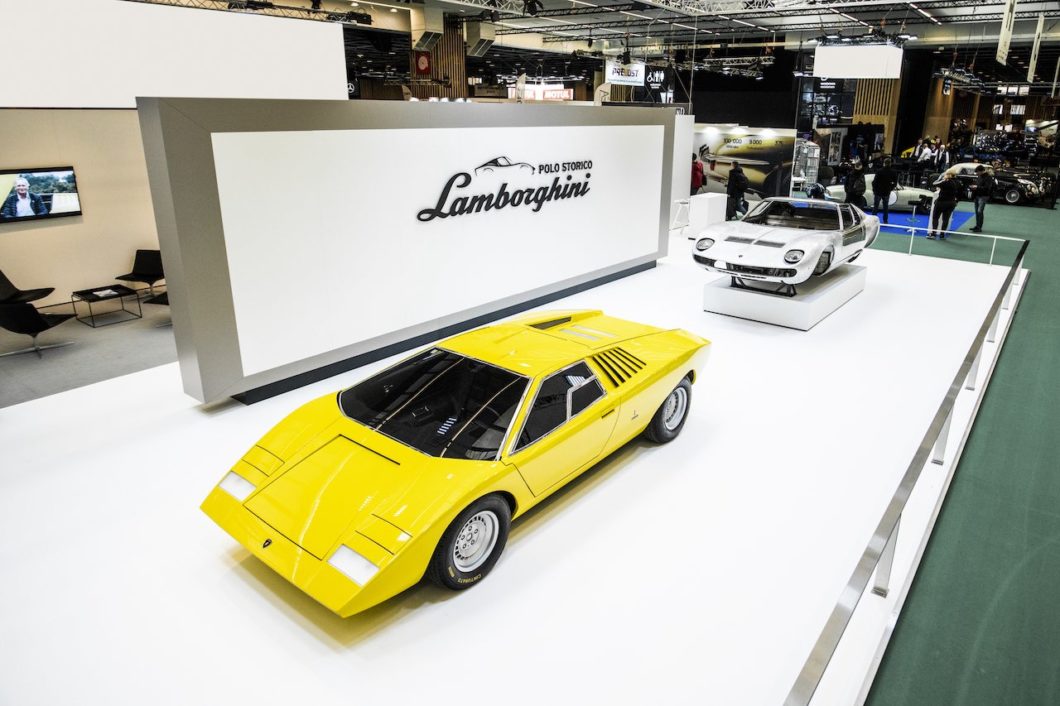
202, 312, 709, 616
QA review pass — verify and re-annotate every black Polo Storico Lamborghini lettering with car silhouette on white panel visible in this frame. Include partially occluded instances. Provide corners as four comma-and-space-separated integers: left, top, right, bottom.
416, 157, 593, 223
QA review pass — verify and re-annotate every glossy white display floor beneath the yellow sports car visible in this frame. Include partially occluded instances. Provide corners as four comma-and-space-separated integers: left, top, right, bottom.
0, 239, 1005, 706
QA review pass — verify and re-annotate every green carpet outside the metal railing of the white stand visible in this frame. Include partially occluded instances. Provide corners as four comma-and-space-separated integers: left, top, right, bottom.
867, 199, 1060, 706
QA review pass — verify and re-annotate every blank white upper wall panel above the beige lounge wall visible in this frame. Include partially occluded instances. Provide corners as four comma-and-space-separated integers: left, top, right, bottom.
0, 0, 347, 107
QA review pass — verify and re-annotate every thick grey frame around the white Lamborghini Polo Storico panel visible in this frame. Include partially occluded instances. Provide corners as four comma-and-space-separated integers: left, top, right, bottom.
137, 98, 676, 403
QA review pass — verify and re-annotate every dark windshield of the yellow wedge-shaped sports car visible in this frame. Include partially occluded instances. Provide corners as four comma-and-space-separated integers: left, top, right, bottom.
338, 348, 529, 460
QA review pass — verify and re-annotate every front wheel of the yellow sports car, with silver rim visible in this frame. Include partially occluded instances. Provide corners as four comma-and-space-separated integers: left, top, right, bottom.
427, 495, 512, 590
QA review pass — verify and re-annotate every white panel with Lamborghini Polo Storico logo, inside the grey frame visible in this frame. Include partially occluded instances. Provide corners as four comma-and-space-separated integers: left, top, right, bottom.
212, 125, 665, 375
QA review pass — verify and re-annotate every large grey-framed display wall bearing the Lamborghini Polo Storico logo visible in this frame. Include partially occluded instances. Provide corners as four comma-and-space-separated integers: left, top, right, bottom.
140, 99, 674, 401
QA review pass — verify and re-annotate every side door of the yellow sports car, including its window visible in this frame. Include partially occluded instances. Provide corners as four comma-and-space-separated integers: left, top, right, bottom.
508, 361, 618, 495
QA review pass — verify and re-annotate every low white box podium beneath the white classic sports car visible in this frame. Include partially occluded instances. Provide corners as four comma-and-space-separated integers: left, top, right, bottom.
703, 265, 866, 331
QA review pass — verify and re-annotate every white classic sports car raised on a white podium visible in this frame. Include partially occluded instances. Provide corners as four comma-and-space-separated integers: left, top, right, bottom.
692, 198, 880, 296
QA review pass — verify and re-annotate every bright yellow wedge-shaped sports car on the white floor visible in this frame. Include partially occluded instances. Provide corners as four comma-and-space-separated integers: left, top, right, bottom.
202, 312, 710, 617
